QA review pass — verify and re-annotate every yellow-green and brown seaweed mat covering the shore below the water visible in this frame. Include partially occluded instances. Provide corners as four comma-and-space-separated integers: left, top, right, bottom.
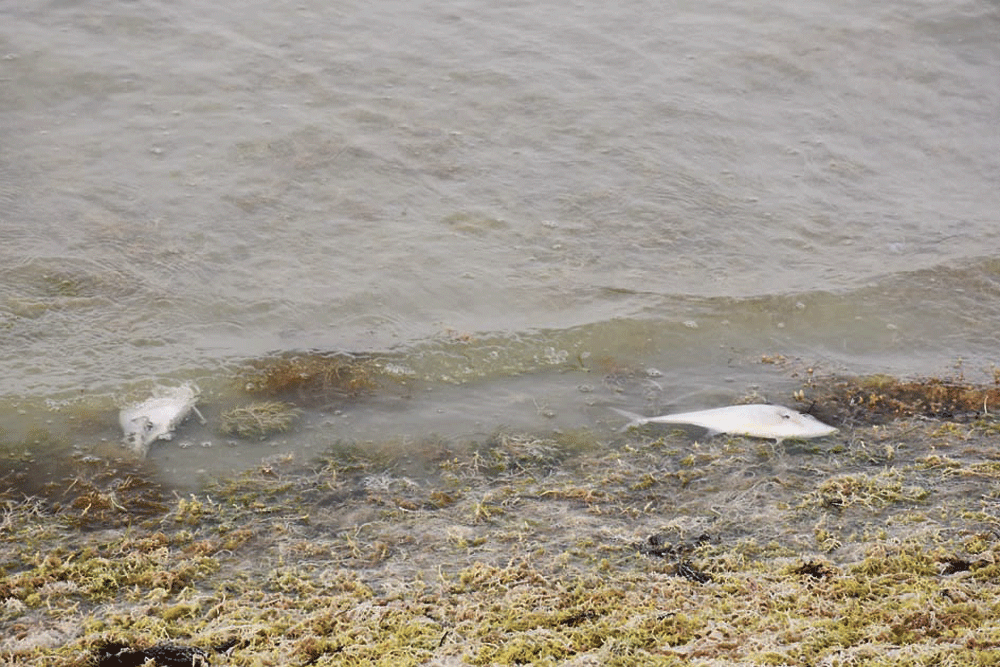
0, 368, 1000, 667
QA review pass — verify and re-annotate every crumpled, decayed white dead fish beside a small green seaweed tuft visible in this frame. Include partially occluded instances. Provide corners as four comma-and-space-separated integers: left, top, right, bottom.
118, 383, 205, 457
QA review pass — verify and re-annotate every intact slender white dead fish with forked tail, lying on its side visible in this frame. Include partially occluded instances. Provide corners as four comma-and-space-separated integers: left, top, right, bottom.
612, 404, 837, 442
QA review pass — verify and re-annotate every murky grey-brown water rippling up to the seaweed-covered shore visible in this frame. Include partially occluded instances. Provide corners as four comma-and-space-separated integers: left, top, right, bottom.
0, 0, 1000, 486
